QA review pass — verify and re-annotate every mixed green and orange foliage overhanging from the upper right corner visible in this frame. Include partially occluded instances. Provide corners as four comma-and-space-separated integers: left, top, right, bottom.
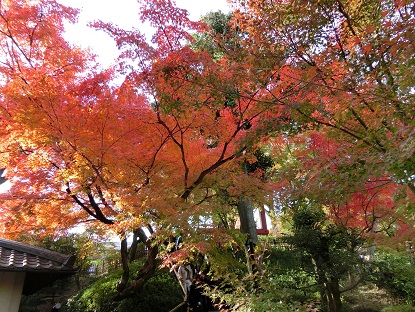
235, 1, 414, 193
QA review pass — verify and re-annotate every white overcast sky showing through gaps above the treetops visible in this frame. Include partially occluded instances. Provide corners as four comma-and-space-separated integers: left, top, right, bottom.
58, 0, 229, 67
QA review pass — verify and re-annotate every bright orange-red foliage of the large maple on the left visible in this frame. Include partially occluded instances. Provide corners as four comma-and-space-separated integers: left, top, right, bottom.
1, 1, 280, 238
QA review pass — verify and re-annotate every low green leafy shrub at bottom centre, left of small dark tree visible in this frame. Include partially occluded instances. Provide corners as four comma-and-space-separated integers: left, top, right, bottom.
208, 241, 318, 312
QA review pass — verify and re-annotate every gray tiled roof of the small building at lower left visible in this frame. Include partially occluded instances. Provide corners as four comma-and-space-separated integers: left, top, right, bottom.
0, 238, 76, 273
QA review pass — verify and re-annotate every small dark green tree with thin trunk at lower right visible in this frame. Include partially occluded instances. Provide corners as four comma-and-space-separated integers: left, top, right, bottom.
285, 200, 363, 311
